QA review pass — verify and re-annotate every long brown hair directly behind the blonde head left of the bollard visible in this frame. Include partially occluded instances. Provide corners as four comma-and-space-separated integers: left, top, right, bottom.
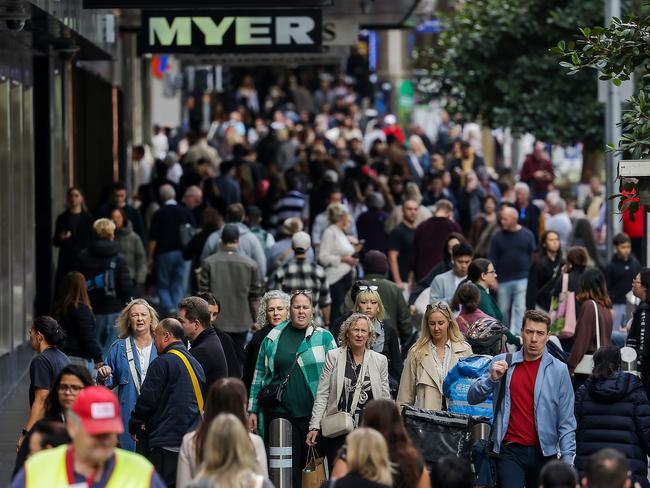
194, 378, 248, 465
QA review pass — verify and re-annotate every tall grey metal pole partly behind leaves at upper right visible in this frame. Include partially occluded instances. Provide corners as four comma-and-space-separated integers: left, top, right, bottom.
605, 0, 622, 261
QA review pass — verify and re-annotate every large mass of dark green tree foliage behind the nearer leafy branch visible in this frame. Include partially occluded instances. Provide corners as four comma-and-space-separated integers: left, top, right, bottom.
425, 0, 604, 148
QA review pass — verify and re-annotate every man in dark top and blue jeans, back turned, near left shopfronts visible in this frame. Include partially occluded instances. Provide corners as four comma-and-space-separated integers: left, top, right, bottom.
148, 185, 196, 316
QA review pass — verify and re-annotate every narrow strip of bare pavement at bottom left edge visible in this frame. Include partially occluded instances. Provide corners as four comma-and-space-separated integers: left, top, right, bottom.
0, 372, 29, 486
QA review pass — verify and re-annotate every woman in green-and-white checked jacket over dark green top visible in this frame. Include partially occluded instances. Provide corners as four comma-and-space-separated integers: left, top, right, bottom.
248, 291, 336, 486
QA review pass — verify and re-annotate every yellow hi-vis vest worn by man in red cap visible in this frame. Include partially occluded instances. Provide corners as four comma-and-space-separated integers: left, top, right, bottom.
25, 445, 154, 488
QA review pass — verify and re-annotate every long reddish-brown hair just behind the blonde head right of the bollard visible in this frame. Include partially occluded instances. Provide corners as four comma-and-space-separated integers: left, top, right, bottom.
363, 400, 424, 488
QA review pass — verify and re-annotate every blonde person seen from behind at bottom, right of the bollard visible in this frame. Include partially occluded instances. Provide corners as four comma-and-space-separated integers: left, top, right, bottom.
326, 427, 393, 488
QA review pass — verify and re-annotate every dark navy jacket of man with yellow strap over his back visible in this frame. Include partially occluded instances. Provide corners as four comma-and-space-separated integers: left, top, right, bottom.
129, 342, 206, 447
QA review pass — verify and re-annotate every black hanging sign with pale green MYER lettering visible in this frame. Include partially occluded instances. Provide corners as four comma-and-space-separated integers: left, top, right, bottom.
140, 10, 322, 54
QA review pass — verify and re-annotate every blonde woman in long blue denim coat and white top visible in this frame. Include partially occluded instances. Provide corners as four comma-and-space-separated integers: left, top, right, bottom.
97, 298, 158, 451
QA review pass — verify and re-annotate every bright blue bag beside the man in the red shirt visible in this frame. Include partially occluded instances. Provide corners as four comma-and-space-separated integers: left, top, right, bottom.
442, 355, 492, 422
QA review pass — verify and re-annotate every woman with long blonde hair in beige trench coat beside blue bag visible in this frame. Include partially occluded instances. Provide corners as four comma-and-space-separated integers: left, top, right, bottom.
397, 301, 472, 410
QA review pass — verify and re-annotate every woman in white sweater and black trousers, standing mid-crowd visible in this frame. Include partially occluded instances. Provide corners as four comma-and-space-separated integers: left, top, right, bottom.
318, 203, 361, 322
